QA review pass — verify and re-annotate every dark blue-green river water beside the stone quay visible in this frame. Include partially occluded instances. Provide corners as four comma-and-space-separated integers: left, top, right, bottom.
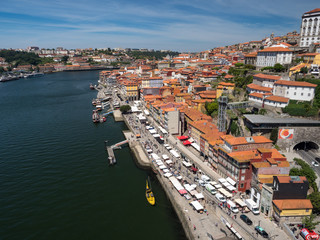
0, 71, 185, 240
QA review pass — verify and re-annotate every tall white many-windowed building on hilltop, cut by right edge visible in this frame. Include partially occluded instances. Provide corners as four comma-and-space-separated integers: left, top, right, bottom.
300, 8, 320, 47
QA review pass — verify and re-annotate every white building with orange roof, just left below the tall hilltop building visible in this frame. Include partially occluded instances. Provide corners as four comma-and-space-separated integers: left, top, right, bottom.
256, 46, 292, 68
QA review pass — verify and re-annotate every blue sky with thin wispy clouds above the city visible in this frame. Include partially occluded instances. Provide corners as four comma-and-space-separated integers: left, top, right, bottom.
0, 0, 320, 52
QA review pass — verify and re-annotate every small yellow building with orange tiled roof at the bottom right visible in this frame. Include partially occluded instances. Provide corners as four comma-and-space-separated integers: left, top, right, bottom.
272, 199, 313, 222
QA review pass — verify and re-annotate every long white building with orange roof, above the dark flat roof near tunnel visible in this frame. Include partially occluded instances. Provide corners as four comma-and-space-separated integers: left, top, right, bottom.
273, 80, 317, 101
